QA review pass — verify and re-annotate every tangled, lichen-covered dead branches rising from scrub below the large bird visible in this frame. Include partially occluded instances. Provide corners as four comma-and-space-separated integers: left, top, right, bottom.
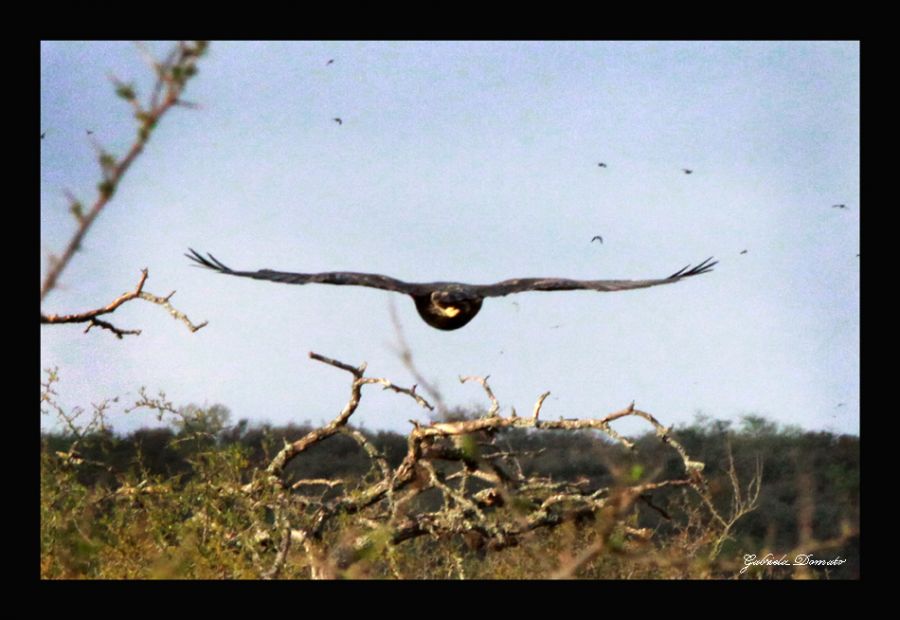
236, 353, 739, 577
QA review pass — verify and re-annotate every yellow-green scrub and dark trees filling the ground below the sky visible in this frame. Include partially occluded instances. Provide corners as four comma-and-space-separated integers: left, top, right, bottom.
41, 368, 859, 579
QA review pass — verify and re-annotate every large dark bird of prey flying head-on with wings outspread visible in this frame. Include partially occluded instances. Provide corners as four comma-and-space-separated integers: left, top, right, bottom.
185, 248, 717, 331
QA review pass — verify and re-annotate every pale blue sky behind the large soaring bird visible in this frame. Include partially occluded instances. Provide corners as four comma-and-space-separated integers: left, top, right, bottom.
35, 41, 860, 433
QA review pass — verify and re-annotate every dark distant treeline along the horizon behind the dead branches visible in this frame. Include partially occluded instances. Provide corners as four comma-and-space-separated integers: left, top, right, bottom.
43, 405, 860, 572
